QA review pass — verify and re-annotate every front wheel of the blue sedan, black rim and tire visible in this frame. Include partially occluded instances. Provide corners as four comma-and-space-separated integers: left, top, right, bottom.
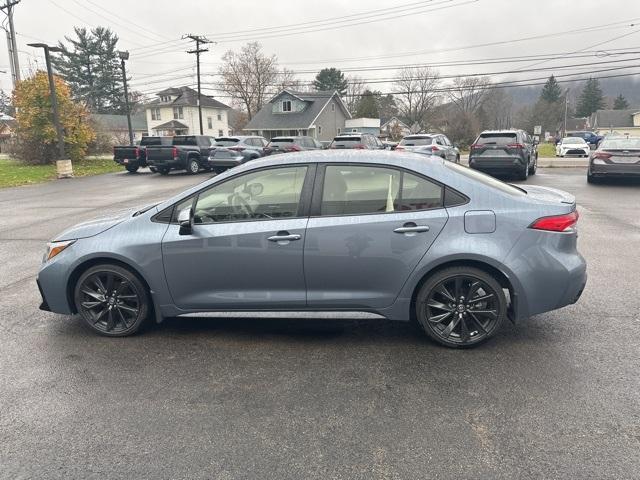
73, 263, 151, 337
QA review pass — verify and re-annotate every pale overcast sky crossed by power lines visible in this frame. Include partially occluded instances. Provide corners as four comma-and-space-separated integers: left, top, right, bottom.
0, 0, 640, 101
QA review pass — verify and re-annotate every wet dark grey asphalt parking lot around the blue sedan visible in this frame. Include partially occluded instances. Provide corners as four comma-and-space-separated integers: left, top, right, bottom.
0, 168, 640, 479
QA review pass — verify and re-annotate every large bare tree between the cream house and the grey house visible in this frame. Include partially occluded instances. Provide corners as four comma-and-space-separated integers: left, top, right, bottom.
220, 42, 280, 120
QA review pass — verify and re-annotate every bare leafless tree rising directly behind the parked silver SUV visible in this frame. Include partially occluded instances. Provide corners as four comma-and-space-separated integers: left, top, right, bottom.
394, 67, 440, 131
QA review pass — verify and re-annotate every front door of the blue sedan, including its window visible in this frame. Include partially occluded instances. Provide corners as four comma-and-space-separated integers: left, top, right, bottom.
162, 165, 310, 310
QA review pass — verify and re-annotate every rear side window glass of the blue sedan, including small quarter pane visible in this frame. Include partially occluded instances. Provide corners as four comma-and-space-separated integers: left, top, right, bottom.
320, 165, 442, 216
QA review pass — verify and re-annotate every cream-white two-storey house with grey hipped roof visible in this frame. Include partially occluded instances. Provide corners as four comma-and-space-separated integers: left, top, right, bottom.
145, 87, 229, 137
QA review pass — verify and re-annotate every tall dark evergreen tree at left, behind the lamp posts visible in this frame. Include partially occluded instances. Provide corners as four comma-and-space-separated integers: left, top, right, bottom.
53, 27, 125, 113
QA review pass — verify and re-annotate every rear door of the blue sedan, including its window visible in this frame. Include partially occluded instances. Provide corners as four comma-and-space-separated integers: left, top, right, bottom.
304, 164, 448, 309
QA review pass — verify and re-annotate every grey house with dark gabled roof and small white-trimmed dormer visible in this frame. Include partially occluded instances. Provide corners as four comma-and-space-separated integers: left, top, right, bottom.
244, 90, 351, 141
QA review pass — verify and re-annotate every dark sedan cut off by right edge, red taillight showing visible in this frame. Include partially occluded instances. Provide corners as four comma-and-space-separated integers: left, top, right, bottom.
587, 135, 640, 183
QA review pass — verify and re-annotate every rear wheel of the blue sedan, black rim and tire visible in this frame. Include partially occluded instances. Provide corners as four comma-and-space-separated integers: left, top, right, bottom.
415, 267, 507, 348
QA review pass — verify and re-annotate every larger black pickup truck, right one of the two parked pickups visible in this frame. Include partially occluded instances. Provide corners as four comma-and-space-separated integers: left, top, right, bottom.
147, 135, 216, 175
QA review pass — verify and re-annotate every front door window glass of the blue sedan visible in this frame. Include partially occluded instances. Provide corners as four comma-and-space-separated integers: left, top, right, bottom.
194, 166, 307, 224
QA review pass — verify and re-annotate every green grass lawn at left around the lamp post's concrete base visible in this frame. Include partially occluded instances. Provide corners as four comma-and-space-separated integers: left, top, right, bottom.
0, 156, 122, 188
